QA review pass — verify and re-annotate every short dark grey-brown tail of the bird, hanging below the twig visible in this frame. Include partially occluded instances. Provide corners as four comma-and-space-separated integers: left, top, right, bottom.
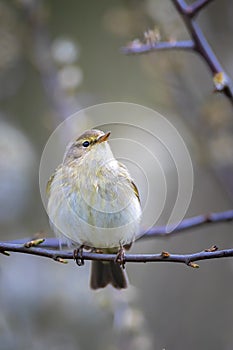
90, 261, 128, 289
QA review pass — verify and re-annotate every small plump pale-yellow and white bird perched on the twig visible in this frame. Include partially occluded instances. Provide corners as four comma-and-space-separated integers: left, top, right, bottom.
47, 130, 141, 289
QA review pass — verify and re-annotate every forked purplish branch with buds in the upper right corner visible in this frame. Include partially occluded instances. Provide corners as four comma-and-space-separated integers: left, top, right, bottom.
122, 0, 233, 103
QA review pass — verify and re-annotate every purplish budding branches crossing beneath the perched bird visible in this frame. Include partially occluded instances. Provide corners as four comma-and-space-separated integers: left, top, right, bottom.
0, 210, 233, 267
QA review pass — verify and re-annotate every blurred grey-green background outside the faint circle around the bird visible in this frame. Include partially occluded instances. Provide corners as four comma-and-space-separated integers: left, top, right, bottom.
0, 0, 233, 350
